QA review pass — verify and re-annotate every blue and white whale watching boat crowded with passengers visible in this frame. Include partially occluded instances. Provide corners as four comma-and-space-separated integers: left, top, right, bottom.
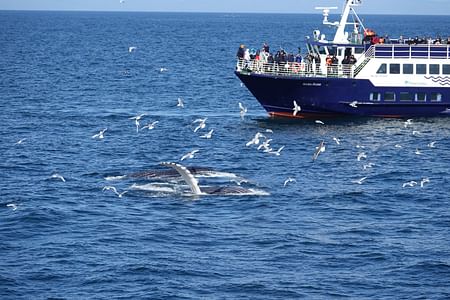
235, 0, 450, 118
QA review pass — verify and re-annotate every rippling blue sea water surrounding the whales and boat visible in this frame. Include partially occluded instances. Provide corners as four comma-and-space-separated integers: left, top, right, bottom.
0, 12, 450, 299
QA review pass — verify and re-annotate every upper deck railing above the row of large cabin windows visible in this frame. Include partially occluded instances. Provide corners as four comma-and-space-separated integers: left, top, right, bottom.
366, 44, 450, 59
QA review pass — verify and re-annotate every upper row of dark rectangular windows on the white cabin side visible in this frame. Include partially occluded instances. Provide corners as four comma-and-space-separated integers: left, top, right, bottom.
377, 64, 450, 75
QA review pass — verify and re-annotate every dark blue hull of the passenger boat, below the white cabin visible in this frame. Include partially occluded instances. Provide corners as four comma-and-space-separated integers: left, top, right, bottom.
235, 71, 450, 118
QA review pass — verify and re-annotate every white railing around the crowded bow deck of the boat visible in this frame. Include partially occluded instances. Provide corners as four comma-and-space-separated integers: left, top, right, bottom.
236, 59, 354, 78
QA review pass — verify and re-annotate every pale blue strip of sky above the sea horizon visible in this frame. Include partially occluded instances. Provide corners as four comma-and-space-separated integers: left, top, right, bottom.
0, 0, 450, 15
